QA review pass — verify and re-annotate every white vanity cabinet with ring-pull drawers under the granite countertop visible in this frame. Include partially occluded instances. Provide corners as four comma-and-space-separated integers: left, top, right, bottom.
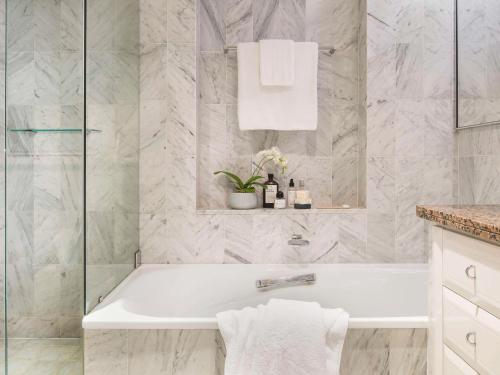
430, 227, 500, 375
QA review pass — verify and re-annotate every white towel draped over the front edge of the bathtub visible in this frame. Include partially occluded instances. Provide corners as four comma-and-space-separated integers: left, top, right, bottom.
217, 299, 349, 375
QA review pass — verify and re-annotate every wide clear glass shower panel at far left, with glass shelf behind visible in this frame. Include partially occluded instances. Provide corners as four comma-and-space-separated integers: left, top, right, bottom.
5, 0, 84, 375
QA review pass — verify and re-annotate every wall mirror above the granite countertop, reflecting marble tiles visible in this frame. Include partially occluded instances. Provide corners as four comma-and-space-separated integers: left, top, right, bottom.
456, 0, 500, 128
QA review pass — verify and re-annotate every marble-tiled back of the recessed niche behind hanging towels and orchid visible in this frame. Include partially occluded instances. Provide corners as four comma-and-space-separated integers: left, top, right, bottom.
197, 0, 366, 209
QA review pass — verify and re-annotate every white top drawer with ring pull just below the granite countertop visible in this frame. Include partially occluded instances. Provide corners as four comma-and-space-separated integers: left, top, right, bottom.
443, 231, 500, 317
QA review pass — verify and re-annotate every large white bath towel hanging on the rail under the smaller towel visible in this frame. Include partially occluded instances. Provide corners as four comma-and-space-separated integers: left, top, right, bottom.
238, 43, 318, 130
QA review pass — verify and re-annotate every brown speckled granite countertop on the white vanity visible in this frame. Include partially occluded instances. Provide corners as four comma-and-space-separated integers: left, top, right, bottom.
417, 205, 500, 245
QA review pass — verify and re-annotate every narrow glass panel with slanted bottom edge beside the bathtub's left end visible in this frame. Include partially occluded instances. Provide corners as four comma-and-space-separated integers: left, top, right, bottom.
85, 0, 139, 311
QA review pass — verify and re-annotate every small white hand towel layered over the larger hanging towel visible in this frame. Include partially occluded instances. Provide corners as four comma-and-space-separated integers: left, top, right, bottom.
259, 39, 295, 86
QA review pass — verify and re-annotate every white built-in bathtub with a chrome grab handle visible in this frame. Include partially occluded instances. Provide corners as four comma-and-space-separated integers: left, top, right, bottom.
83, 264, 428, 329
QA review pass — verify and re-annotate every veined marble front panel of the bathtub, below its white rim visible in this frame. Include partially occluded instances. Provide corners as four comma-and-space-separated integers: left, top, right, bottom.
84, 329, 427, 375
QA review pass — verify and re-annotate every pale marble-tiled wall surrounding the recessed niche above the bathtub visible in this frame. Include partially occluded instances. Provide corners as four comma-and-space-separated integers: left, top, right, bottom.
140, 0, 458, 263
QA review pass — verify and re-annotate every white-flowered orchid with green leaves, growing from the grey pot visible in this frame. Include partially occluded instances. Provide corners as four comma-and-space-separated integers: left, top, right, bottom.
214, 147, 288, 193
